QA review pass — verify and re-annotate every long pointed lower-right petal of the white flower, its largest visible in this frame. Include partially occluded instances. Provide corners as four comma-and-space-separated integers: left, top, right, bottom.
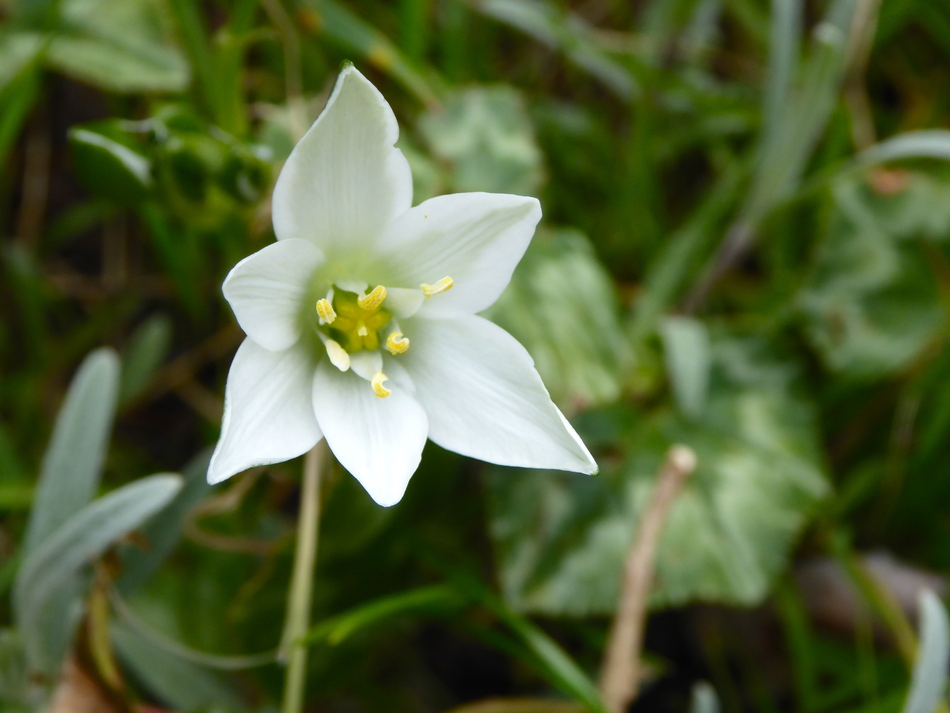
401, 315, 597, 473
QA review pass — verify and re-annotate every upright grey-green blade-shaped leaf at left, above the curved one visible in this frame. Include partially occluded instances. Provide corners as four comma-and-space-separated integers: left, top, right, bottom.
23, 349, 119, 552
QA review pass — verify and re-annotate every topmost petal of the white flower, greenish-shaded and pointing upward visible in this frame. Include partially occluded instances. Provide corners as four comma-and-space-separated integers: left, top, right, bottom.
273, 66, 412, 266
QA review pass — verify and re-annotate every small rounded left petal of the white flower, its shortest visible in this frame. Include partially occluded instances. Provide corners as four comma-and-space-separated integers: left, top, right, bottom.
222, 240, 323, 351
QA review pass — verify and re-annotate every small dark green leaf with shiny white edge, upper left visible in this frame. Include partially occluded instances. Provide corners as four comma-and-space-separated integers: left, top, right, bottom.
67, 122, 152, 205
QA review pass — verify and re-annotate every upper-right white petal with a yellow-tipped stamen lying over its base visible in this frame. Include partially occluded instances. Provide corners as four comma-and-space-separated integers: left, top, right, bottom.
376, 193, 541, 316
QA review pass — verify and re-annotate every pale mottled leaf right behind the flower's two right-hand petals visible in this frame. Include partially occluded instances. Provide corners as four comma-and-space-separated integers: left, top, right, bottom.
491, 230, 630, 406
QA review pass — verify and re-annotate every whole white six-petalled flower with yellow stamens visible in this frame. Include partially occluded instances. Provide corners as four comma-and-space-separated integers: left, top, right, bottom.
208, 66, 597, 506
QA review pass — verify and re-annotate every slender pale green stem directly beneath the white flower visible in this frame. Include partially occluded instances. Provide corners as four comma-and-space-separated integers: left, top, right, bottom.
280, 441, 324, 713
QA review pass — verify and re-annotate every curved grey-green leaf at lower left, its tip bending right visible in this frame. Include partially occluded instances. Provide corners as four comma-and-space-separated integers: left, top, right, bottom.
13, 475, 181, 678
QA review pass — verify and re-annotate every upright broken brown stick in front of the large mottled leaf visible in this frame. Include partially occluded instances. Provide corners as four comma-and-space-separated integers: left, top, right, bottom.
600, 445, 696, 713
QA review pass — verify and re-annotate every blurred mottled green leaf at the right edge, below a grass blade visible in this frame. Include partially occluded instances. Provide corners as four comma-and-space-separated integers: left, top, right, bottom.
799, 179, 950, 379
